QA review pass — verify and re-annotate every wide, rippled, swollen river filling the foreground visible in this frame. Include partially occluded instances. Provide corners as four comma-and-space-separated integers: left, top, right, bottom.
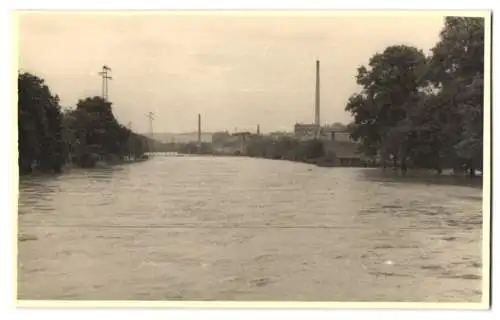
18, 157, 482, 302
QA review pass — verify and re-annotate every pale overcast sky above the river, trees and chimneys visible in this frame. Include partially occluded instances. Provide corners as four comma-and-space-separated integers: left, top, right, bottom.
19, 12, 444, 132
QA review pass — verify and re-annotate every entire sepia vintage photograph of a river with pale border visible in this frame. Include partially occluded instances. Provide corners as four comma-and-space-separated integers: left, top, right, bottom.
15, 11, 491, 307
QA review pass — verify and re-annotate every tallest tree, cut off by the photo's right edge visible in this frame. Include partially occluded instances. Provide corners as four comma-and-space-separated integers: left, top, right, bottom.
429, 17, 484, 175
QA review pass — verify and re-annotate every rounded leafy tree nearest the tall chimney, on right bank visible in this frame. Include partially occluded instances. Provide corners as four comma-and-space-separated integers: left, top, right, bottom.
346, 45, 427, 170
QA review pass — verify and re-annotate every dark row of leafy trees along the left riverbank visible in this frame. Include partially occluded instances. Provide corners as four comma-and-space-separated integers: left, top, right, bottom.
18, 72, 150, 174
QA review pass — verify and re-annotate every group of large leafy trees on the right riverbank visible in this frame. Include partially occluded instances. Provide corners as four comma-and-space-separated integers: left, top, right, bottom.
345, 17, 485, 176
